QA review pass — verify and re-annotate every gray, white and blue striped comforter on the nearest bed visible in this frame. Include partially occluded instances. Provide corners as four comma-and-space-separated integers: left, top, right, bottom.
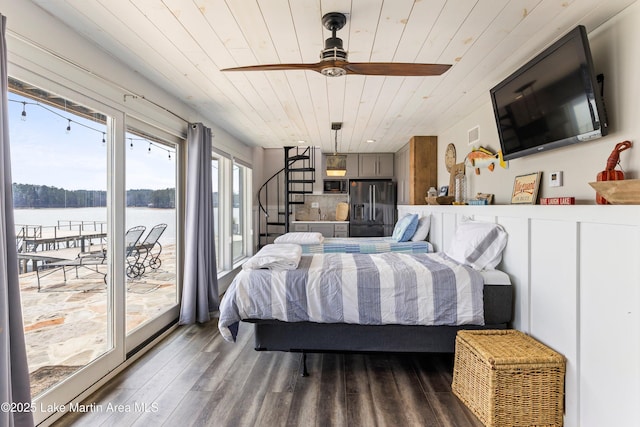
218, 253, 484, 341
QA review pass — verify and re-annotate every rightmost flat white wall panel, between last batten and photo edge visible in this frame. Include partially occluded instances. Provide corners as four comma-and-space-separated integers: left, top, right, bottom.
578, 223, 640, 426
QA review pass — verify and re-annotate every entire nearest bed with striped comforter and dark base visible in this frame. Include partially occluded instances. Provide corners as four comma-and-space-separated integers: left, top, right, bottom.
218, 221, 513, 375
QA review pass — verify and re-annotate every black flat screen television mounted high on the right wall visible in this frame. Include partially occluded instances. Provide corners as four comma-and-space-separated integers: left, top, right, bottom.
490, 26, 607, 160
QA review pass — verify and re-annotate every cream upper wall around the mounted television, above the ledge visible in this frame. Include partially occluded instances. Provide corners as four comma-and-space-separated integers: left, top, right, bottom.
438, 3, 640, 204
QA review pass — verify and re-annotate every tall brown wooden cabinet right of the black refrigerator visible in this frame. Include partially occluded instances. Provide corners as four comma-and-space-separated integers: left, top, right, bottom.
396, 136, 438, 205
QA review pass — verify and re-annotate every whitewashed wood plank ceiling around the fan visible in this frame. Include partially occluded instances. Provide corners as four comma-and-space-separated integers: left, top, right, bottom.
32, 0, 635, 152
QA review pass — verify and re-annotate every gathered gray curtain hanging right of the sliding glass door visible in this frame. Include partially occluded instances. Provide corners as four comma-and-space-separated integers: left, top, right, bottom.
180, 123, 219, 325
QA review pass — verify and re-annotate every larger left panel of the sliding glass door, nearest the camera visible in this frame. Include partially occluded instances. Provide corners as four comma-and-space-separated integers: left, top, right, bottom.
9, 79, 124, 421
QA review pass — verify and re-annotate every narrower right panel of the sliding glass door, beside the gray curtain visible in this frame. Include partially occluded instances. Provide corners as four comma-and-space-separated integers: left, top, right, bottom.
125, 126, 181, 352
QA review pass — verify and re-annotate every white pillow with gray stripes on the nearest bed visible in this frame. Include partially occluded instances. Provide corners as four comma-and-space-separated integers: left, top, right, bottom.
445, 221, 507, 270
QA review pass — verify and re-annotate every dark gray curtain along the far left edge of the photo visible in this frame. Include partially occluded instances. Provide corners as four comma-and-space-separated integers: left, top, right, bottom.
0, 15, 33, 427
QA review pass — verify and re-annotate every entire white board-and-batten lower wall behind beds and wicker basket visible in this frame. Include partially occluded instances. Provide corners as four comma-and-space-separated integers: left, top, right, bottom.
398, 205, 640, 427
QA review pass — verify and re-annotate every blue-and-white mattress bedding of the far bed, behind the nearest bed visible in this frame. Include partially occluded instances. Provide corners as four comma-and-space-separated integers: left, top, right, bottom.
300, 237, 433, 254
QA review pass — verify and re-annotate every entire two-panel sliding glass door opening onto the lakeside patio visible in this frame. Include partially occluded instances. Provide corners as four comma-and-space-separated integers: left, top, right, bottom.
9, 78, 182, 423
